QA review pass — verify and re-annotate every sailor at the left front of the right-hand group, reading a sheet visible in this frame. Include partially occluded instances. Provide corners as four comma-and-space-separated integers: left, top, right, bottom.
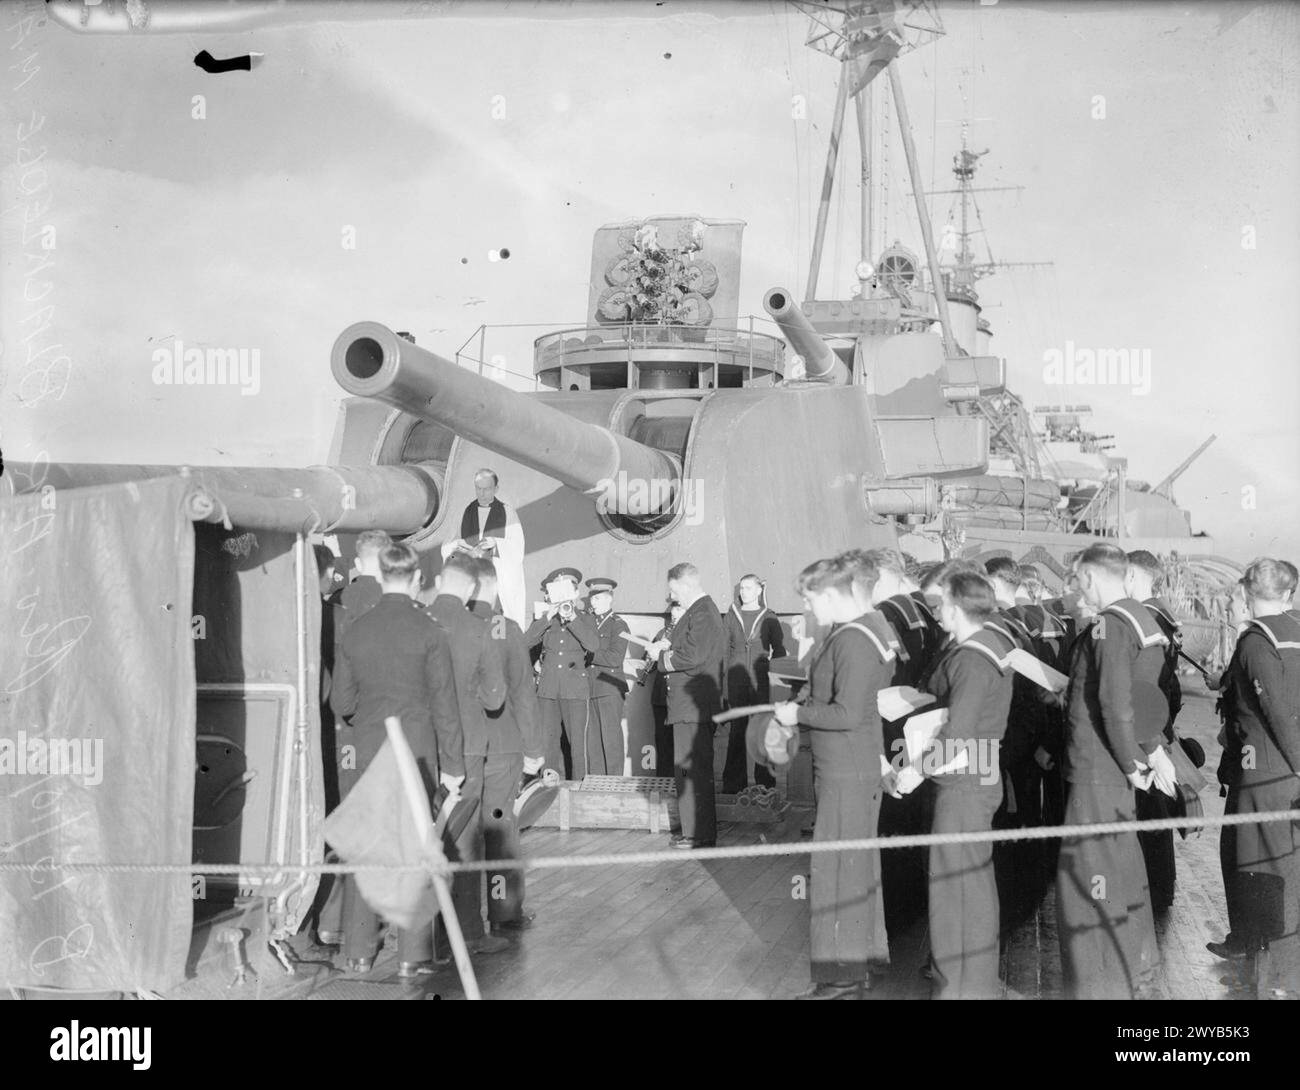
774, 557, 894, 999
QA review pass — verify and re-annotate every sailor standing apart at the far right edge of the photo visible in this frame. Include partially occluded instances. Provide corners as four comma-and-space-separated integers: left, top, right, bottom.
1209, 558, 1300, 999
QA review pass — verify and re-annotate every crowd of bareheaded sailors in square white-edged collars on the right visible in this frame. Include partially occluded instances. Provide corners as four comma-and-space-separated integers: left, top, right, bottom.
774, 542, 1300, 999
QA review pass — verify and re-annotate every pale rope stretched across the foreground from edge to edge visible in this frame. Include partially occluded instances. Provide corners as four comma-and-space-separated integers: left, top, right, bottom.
0, 810, 1300, 878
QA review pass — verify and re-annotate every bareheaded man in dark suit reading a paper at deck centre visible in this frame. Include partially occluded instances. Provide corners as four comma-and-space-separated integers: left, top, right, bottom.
647, 563, 727, 851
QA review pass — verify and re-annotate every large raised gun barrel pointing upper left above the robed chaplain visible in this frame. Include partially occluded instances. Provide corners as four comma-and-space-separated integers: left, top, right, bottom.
330, 321, 681, 516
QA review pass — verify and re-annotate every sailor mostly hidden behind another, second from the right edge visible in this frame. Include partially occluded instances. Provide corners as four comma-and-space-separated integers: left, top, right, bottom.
1125, 549, 1183, 912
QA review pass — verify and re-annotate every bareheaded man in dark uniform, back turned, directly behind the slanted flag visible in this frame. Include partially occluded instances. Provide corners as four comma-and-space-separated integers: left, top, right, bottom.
330, 545, 465, 972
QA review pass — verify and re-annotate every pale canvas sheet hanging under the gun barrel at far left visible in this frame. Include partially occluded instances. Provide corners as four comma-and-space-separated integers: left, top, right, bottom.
0, 477, 195, 991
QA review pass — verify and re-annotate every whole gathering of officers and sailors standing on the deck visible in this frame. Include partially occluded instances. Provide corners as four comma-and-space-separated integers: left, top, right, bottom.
309, 471, 1300, 999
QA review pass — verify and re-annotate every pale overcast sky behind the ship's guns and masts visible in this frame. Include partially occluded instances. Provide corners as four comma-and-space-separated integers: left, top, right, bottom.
0, 0, 1300, 559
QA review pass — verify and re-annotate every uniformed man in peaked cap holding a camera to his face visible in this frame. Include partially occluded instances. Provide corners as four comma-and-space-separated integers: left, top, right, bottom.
522, 567, 601, 779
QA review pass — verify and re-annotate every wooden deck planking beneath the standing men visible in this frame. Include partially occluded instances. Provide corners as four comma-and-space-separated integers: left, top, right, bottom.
301, 676, 1244, 999
